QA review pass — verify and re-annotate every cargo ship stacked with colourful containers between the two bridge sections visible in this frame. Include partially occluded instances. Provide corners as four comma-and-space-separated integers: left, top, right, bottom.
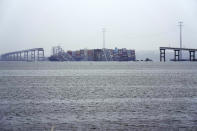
51, 46, 136, 61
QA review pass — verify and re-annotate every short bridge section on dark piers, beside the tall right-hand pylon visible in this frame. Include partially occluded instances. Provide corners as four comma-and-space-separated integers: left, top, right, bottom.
160, 47, 197, 61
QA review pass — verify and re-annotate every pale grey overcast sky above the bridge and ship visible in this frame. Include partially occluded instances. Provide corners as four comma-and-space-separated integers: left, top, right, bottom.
0, 0, 197, 55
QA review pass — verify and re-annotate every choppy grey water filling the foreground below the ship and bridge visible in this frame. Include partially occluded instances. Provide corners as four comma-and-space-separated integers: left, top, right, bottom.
0, 62, 197, 131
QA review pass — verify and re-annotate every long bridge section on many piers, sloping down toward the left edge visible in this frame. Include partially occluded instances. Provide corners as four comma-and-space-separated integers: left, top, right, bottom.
1, 48, 44, 61
